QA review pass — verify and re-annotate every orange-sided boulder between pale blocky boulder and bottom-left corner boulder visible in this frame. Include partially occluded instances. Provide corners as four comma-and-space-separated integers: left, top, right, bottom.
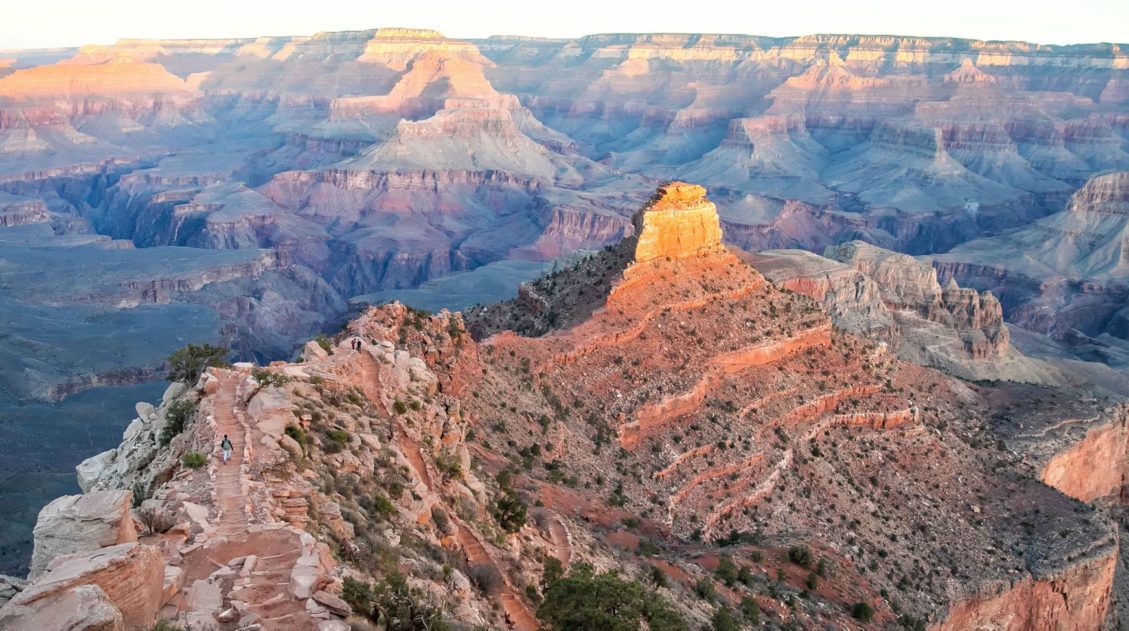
12, 543, 165, 631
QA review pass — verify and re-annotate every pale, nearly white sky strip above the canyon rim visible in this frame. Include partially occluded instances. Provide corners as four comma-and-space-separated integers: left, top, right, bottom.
0, 0, 1129, 50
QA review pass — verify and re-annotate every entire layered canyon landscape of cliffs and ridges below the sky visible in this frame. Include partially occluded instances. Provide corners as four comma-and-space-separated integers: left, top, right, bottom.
0, 22, 1129, 630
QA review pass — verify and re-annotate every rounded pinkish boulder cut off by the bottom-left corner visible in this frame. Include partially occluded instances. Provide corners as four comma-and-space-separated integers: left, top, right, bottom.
0, 585, 125, 631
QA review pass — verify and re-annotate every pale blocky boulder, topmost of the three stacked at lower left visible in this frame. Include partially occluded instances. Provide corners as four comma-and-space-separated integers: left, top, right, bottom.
28, 491, 138, 580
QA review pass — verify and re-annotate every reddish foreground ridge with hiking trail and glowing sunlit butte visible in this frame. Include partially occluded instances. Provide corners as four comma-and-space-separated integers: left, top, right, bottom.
0, 183, 1124, 630
